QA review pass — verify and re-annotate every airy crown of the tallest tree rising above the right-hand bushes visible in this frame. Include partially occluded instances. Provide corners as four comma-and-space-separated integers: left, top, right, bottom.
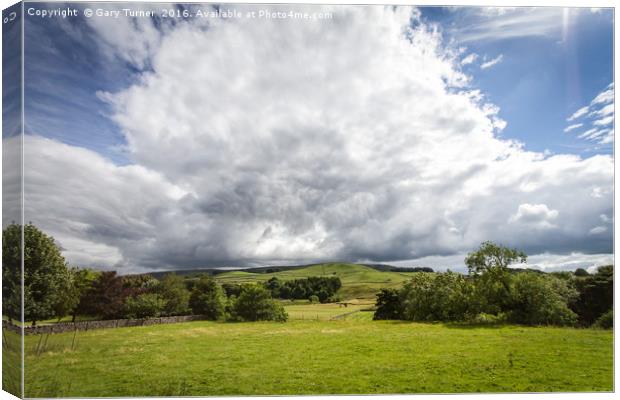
465, 241, 527, 275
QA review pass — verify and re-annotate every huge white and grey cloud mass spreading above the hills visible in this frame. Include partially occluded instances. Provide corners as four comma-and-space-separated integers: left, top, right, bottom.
13, 6, 613, 270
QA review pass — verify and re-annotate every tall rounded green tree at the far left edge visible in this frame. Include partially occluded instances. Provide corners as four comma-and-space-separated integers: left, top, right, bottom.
2, 224, 69, 325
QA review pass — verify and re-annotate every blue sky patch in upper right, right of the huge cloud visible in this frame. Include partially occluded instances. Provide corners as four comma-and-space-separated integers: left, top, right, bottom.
422, 8, 613, 155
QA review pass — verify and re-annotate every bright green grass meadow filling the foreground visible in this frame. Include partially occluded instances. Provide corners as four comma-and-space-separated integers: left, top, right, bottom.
25, 318, 613, 397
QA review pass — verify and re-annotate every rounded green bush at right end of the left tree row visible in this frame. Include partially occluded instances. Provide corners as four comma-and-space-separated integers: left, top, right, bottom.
233, 284, 288, 322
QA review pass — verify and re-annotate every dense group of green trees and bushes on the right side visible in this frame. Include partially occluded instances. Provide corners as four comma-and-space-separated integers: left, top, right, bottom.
374, 242, 613, 328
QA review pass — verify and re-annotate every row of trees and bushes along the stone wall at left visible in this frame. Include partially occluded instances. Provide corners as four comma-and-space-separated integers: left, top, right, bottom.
2, 224, 287, 325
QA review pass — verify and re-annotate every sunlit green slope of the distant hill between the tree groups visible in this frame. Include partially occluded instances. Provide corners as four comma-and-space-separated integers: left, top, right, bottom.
215, 263, 415, 299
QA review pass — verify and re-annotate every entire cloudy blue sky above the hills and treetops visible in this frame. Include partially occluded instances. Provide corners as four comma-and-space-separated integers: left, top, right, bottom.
3, 3, 614, 273
